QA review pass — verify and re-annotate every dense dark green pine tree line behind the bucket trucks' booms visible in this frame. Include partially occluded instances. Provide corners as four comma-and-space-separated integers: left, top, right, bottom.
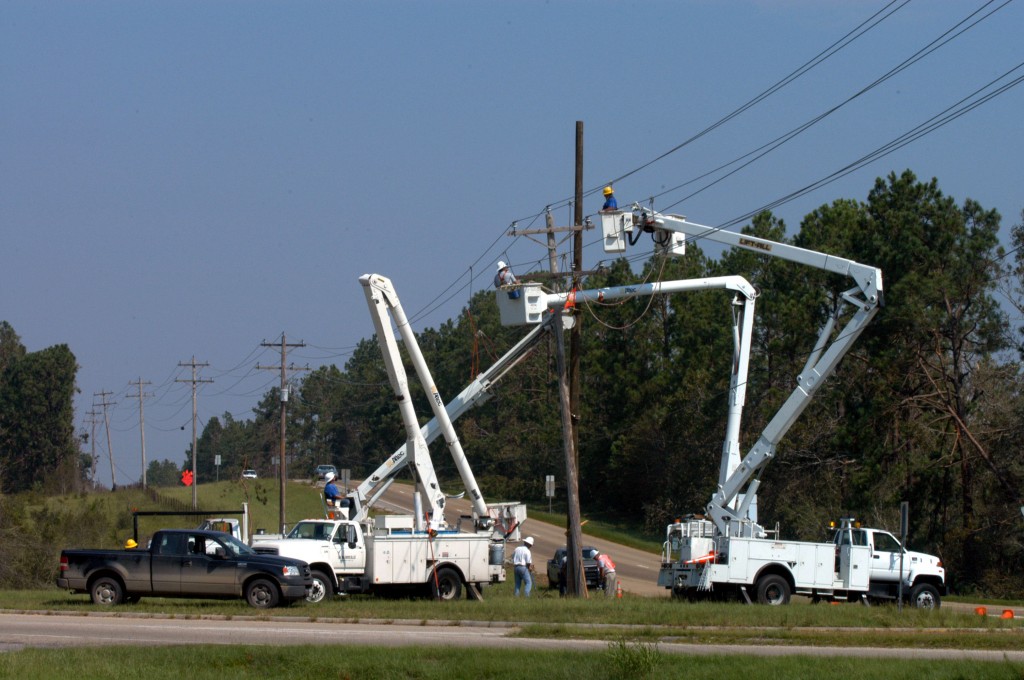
0, 171, 1024, 596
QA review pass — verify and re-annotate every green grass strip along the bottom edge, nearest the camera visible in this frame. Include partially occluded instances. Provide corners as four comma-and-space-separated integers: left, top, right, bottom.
0, 641, 1024, 680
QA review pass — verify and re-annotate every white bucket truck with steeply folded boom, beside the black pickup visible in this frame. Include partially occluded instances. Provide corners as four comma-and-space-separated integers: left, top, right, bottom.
253, 274, 526, 602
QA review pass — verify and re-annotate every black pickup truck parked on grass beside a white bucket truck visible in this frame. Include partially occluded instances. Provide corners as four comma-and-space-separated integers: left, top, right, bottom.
57, 529, 312, 609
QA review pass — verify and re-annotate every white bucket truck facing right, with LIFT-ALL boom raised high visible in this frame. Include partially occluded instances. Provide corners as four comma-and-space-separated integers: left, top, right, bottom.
600, 206, 945, 607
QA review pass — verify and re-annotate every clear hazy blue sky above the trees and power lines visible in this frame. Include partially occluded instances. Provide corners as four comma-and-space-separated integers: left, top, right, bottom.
0, 0, 1024, 484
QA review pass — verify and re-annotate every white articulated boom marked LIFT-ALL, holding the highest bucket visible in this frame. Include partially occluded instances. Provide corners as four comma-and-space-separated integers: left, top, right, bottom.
605, 206, 883, 537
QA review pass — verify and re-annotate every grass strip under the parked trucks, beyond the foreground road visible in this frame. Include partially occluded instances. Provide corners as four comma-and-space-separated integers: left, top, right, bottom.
9, 582, 1024, 649
